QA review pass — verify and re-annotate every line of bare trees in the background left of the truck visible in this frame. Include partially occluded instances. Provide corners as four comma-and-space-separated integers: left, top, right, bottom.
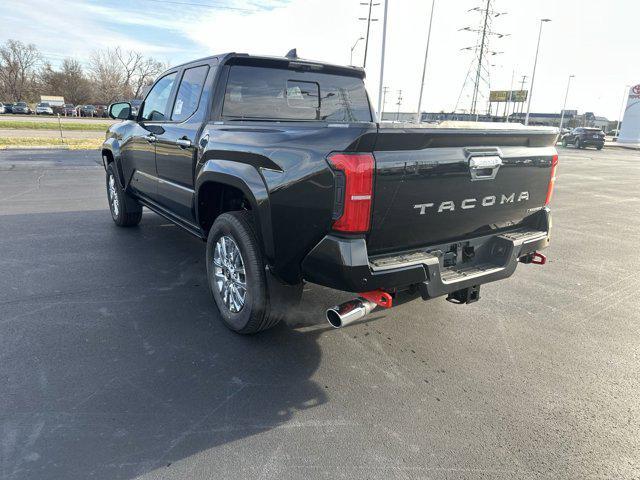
0, 40, 167, 105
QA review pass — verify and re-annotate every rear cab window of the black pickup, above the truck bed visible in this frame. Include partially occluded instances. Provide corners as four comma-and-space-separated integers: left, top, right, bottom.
222, 65, 371, 122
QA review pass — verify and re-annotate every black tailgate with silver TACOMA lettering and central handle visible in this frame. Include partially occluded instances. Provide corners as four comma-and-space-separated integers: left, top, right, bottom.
367, 128, 557, 254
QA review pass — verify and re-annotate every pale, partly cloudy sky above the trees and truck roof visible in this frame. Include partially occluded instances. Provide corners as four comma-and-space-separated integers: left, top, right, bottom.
0, 0, 640, 119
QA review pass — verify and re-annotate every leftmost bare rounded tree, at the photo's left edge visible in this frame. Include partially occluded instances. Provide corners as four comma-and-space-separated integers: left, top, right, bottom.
0, 40, 41, 100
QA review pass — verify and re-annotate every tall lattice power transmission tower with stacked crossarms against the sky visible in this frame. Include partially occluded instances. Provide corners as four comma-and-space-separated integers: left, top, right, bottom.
454, 0, 509, 121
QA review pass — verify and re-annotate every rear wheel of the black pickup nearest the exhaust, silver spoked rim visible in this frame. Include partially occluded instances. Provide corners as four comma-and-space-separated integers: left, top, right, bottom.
207, 211, 302, 334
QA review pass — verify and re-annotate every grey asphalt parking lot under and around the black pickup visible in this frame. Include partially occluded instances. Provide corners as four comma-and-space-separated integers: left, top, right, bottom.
0, 148, 640, 480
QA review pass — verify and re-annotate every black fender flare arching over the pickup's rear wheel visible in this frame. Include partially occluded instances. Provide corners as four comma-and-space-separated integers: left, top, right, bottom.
195, 158, 275, 260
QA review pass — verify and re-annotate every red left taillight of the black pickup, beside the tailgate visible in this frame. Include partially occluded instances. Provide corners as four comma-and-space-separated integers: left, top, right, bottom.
329, 153, 374, 233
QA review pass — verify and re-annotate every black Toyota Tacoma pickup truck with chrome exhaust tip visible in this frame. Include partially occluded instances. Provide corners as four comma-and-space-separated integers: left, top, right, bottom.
102, 53, 558, 333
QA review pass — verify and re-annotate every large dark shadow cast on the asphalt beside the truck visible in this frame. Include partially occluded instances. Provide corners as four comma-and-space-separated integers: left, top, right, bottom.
0, 211, 332, 479
